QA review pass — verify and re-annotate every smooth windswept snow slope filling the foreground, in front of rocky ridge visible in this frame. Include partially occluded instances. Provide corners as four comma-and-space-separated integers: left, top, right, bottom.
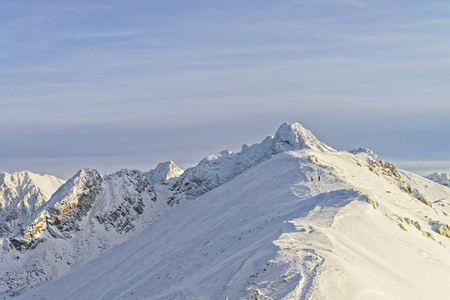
12, 135, 450, 300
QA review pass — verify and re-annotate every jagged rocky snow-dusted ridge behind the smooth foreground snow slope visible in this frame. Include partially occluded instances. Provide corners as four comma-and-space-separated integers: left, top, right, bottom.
0, 123, 335, 292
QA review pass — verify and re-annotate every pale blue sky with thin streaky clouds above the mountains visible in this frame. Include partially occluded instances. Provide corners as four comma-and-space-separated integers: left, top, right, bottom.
0, 0, 450, 178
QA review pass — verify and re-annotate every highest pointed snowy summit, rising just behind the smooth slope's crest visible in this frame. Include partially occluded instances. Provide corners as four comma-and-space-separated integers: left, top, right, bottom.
274, 123, 334, 154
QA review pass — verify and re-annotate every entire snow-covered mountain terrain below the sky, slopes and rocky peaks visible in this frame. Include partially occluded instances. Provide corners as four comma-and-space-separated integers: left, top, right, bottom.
0, 123, 450, 299
